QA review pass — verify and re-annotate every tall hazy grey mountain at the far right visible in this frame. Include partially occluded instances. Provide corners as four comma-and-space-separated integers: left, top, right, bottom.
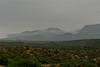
77, 24, 100, 39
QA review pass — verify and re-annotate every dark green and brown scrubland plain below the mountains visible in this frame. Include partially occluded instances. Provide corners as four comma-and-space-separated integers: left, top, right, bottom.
0, 40, 100, 67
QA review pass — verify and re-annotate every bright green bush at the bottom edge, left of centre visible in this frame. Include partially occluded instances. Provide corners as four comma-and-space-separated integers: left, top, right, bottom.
8, 57, 41, 67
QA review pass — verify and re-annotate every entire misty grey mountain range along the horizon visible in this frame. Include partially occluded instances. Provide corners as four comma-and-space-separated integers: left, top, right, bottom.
3, 24, 100, 41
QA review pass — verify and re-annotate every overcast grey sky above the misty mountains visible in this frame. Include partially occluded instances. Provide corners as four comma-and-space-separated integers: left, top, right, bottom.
0, 0, 100, 37
